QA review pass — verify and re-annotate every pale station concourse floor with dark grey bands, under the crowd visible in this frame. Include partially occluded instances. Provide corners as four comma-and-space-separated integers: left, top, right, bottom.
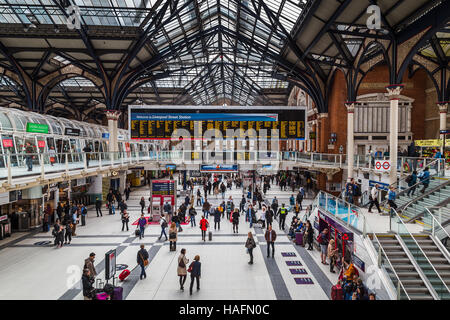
0, 185, 337, 300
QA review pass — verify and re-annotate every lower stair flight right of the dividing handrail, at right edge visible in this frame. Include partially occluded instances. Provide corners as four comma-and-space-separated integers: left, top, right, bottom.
401, 234, 450, 299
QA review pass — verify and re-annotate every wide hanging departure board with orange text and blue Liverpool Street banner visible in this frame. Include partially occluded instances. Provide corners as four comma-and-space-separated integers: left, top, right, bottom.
129, 106, 306, 140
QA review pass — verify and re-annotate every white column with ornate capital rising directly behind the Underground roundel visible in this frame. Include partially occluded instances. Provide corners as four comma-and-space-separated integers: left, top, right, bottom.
386, 84, 403, 184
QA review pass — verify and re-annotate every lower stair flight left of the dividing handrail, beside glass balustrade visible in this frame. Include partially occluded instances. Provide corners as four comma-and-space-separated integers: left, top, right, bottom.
376, 234, 434, 300
